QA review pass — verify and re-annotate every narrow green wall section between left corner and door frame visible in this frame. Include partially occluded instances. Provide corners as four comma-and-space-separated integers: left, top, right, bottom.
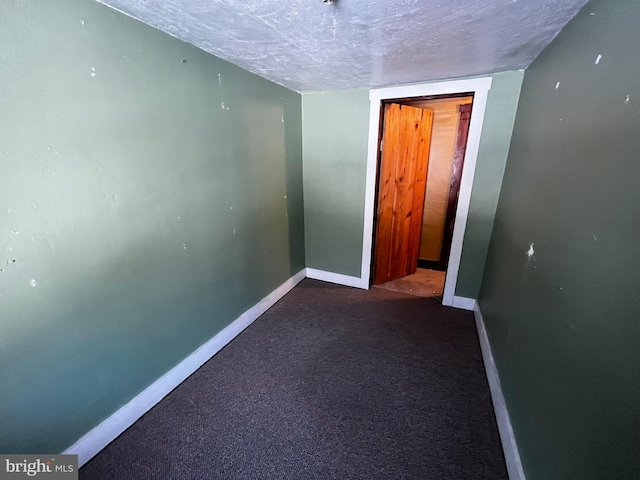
302, 90, 369, 277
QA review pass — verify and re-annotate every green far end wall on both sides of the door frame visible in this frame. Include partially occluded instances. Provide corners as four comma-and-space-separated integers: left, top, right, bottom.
302, 71, 523, 292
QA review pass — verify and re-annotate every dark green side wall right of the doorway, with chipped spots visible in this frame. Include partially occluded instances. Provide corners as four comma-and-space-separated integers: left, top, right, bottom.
479, 0, 640, 480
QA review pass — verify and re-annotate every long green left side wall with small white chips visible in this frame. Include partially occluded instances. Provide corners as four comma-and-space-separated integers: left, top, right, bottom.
0, 0, 304, 453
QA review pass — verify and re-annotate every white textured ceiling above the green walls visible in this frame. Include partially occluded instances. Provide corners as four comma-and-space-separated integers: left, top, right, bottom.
99, 0, 586, 92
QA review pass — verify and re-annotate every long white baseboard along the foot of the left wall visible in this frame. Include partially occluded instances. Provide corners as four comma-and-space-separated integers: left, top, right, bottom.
62, 269, 306, 467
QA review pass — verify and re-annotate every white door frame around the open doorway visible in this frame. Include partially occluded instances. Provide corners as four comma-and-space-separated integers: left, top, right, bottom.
360, 77, 492, 306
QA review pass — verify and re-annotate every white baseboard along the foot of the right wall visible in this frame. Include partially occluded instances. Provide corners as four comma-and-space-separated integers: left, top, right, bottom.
473, 302, 526, 480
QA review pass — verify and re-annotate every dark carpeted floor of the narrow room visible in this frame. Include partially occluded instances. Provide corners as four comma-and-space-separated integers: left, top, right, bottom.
80, 279, 508, 480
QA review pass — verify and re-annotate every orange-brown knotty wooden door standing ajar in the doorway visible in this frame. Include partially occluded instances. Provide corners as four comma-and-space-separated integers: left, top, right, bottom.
373, 103, 433, 284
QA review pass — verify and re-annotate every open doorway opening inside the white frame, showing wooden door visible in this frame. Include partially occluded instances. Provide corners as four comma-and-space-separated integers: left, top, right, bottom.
372, 94, 473, 298
